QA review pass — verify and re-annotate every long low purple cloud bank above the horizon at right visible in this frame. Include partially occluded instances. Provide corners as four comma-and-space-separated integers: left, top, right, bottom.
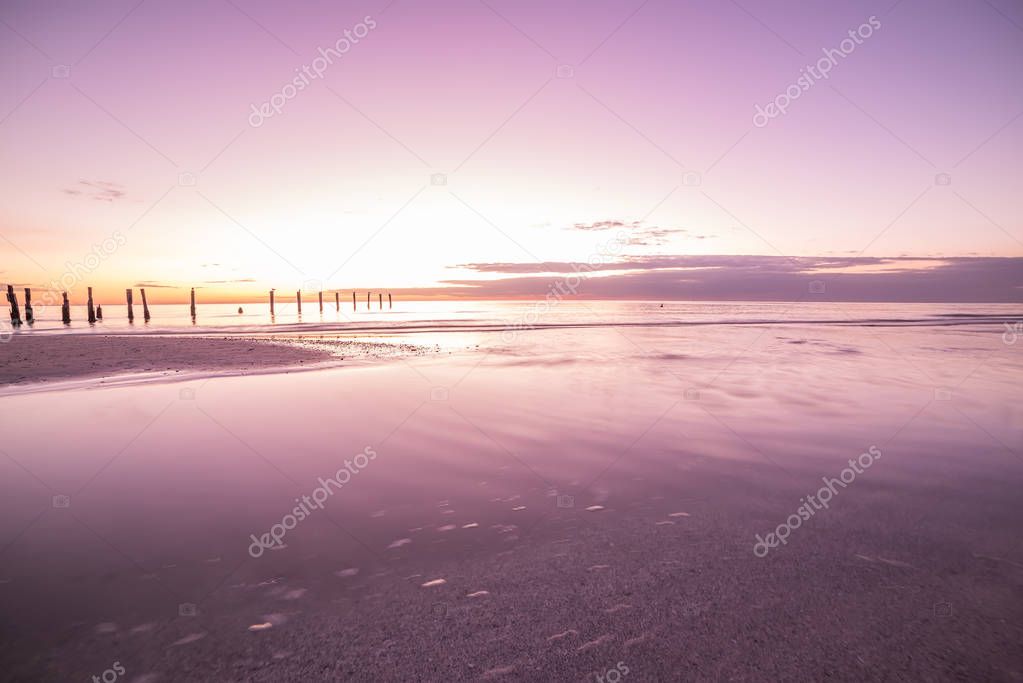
435, 255, 1023, 303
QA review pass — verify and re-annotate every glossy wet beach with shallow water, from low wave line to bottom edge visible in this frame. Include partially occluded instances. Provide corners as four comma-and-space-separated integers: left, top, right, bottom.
0, 304, 1023, 682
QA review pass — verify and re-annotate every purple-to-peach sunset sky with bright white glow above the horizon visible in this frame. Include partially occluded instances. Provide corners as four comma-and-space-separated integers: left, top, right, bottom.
0, 0, 1023, 302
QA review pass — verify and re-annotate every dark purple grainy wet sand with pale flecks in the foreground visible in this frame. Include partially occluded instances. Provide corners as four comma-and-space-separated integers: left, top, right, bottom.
7, 447, 1023, 682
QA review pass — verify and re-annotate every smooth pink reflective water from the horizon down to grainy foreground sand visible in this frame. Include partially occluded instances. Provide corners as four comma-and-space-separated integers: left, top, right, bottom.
0, 302, 1023, 680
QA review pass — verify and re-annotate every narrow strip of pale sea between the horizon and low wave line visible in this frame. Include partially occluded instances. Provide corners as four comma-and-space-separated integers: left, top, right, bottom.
12, 297, 1023, 334
